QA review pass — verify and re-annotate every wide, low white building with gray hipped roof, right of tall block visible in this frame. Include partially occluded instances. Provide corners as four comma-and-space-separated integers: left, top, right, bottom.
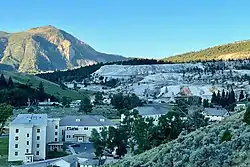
60, 115, 115, 142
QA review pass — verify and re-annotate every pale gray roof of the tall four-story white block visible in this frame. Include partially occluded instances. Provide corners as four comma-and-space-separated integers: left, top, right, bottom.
11, 114, 47, 126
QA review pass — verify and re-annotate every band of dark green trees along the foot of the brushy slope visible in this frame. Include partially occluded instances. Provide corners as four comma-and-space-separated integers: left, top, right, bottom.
90, 102, 208, 161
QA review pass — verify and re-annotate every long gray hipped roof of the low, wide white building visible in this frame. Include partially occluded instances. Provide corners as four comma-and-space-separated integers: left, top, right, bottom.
59, 115, 115, 126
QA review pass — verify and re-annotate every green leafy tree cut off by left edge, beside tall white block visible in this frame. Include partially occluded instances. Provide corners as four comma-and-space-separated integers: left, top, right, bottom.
0, 103, 13, 135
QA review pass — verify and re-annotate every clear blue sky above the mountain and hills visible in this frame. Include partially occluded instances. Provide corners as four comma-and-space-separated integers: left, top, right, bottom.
0, 0, 250, 58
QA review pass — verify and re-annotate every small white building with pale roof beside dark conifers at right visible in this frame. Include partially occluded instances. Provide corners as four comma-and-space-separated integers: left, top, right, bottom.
203, 107, 229, 122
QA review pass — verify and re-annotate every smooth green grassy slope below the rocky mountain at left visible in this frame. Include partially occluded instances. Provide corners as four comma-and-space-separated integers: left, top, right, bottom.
3, 71, 88, 99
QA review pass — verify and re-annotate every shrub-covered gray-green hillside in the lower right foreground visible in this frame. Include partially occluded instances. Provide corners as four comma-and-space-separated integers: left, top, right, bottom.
107, 111, 250, 167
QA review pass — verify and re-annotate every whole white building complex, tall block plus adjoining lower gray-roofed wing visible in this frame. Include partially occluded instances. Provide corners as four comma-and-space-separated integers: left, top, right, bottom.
8, 114, 115, 163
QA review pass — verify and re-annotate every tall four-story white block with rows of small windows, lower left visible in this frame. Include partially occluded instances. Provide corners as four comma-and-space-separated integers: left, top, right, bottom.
8, 114, 47, 162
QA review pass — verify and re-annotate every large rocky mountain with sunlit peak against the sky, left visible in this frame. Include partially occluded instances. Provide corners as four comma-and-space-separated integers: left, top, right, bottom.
0, 26, 125, 72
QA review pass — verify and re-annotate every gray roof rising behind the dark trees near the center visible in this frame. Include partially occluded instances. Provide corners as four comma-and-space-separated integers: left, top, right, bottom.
133, 104, 169, 116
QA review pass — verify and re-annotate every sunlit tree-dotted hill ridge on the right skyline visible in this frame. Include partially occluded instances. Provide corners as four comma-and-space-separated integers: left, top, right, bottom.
163, 40, 250, 62
